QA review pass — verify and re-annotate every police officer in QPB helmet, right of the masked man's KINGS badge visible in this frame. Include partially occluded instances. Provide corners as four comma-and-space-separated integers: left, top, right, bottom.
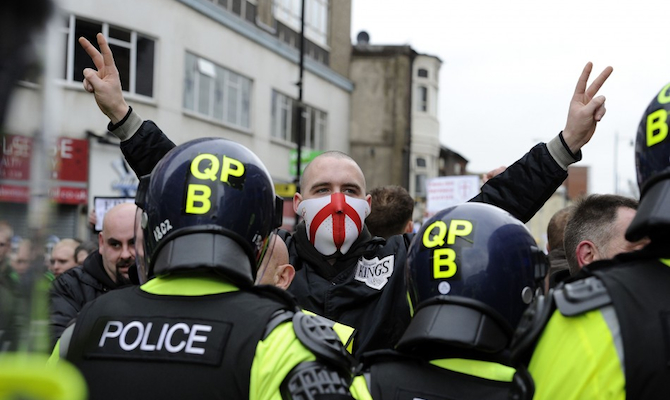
356, 203, 547, 400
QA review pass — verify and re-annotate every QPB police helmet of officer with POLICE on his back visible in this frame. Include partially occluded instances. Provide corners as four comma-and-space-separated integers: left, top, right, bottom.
135, 138, 281, 285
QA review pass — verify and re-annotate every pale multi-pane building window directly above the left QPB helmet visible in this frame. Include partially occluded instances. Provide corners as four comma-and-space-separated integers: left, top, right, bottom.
184, 53, 251, 129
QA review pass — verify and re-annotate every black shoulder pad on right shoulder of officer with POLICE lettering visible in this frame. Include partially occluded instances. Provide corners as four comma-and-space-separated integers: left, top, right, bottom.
293, 312, 355, 372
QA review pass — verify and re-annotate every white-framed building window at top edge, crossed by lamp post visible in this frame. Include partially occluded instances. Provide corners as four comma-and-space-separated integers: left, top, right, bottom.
274, 0, 328, 47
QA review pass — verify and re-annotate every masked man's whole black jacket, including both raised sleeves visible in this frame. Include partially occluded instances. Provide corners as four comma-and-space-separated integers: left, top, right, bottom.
121, 121, 567, 355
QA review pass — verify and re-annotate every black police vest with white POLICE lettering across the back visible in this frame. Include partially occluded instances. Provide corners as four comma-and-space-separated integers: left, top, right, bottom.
61, 287, 356, 399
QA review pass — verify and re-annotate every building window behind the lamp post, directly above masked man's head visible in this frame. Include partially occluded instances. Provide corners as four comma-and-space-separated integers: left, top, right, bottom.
271, 90, 328, 150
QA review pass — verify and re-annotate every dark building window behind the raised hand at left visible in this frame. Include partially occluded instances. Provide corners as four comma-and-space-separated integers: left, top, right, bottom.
61, 15, 155, 97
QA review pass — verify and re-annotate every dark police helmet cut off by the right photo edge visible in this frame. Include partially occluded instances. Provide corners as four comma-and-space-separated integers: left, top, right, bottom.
635, 83, 670, 193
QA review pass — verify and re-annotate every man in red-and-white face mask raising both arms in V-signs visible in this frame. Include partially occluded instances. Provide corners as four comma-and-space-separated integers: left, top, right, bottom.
80, 34, 612, 354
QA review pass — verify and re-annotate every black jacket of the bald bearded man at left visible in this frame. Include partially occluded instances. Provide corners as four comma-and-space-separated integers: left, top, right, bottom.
49, 251, 125, 345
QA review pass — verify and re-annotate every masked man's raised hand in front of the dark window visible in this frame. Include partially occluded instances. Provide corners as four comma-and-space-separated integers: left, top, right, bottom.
79, 33, 128, 124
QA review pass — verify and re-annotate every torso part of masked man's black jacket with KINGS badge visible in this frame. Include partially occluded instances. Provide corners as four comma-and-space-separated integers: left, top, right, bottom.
287, 223, 410, 355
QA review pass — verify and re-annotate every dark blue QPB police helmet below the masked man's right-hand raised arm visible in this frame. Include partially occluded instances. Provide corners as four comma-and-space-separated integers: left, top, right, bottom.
406, 203, 547, 339
